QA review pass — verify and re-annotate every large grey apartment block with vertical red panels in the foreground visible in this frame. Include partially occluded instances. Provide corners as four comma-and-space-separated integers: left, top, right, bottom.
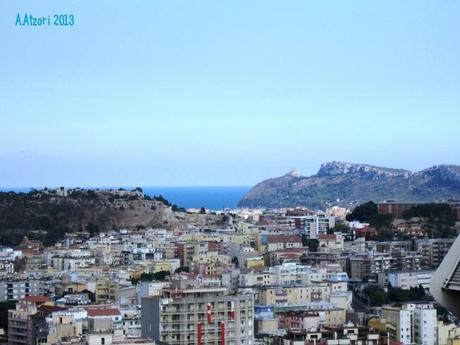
141, 287, 254, 345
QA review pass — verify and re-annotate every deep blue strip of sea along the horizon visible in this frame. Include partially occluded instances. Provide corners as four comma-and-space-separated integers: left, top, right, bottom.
0, 186, 251, 211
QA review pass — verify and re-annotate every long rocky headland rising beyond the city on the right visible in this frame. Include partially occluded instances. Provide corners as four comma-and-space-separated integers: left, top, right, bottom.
238, 162, 460, 209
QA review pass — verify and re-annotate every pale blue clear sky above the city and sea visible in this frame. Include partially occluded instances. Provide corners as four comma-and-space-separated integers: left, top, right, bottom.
0, 0, 460, 187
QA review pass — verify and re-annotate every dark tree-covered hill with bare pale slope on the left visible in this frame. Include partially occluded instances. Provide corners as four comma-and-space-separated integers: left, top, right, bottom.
0, 188, 226, 245
